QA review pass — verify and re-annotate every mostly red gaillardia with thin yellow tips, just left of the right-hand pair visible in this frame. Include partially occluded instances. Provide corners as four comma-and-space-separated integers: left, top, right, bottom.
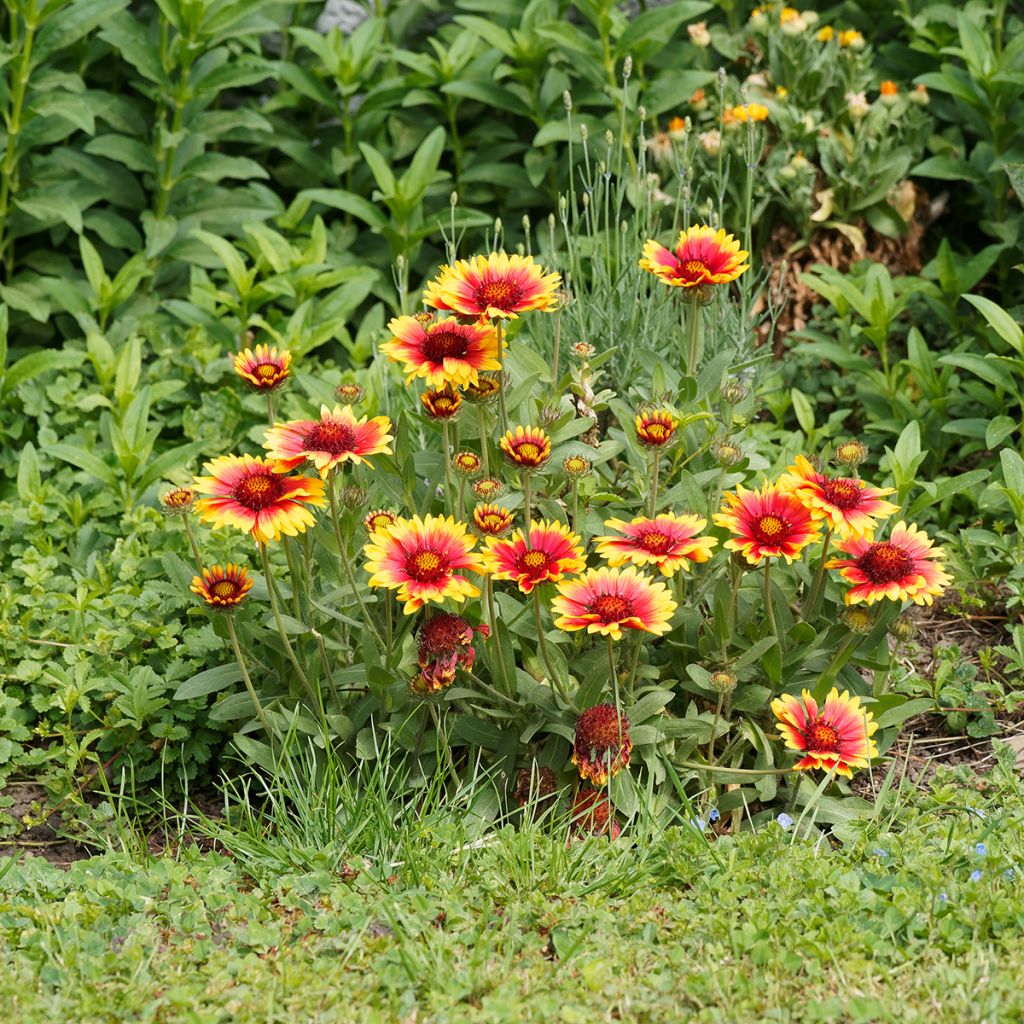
715, 483, 820, 565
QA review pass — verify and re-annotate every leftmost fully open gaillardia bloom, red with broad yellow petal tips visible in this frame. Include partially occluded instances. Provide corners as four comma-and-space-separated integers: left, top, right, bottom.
196, 455, 327, 544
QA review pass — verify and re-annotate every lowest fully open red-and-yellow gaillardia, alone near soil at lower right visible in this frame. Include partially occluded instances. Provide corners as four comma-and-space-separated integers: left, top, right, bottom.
771, 686, 879, 778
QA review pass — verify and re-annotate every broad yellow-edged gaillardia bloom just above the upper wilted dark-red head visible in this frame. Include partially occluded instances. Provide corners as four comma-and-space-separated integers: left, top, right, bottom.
362, 515, 486, 615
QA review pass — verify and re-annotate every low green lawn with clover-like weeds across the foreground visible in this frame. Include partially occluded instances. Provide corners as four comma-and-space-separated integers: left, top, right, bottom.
0, 766, 1024, 1024
